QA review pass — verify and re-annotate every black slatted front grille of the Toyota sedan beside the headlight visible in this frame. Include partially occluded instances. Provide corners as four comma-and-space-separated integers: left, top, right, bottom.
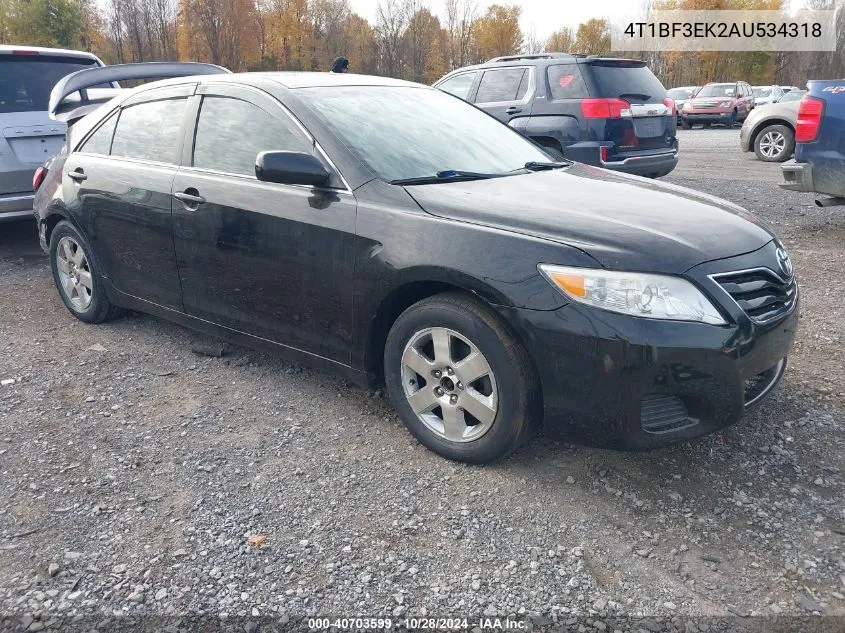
713, 268, 798, 323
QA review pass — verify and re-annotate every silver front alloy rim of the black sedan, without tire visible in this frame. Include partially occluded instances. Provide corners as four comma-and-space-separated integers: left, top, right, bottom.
402, 327, 499, 442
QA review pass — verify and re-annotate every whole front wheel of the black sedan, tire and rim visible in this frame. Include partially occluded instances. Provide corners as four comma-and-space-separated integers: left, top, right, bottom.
384, 293, 541, 464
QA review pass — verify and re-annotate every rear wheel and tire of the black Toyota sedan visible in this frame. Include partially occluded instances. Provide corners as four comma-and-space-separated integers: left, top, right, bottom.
50, 220, 123, 323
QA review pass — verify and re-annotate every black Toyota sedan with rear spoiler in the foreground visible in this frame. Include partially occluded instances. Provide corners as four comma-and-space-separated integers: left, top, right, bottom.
36, 67, 798, 462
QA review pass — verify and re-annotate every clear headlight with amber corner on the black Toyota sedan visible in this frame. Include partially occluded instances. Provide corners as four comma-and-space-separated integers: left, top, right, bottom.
538, 264, 725, 325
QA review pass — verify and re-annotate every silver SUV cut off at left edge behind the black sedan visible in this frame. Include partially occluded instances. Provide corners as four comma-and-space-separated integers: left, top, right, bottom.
0, 45, 104, 221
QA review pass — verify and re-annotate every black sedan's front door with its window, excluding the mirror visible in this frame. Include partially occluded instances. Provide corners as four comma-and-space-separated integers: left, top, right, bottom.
173, 85, 356, 364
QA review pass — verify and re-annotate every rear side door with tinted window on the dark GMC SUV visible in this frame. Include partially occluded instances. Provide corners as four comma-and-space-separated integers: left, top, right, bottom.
474, 66, 534, 123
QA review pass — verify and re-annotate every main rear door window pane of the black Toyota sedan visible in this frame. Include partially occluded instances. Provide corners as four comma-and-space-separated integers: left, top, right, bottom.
111, 99, 187, 163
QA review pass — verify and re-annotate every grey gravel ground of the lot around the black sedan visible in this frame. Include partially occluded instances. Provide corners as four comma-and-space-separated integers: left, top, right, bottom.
0, 129, 845, 633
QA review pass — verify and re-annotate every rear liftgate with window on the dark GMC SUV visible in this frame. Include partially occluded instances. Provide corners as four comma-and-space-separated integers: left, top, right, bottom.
581, 59, 677, 155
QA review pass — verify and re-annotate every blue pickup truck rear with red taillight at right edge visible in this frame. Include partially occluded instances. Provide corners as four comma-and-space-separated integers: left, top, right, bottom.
780, 79, 845, 207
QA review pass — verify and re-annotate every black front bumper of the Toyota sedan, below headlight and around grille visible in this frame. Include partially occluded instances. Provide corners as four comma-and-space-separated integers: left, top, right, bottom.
494, 242, 800, 450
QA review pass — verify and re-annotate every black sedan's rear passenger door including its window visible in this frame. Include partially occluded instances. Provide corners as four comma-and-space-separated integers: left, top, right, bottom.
63, 85, 194, 310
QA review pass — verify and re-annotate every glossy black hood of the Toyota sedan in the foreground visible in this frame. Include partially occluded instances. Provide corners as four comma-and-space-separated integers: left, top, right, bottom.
406, 164, 775, 274
